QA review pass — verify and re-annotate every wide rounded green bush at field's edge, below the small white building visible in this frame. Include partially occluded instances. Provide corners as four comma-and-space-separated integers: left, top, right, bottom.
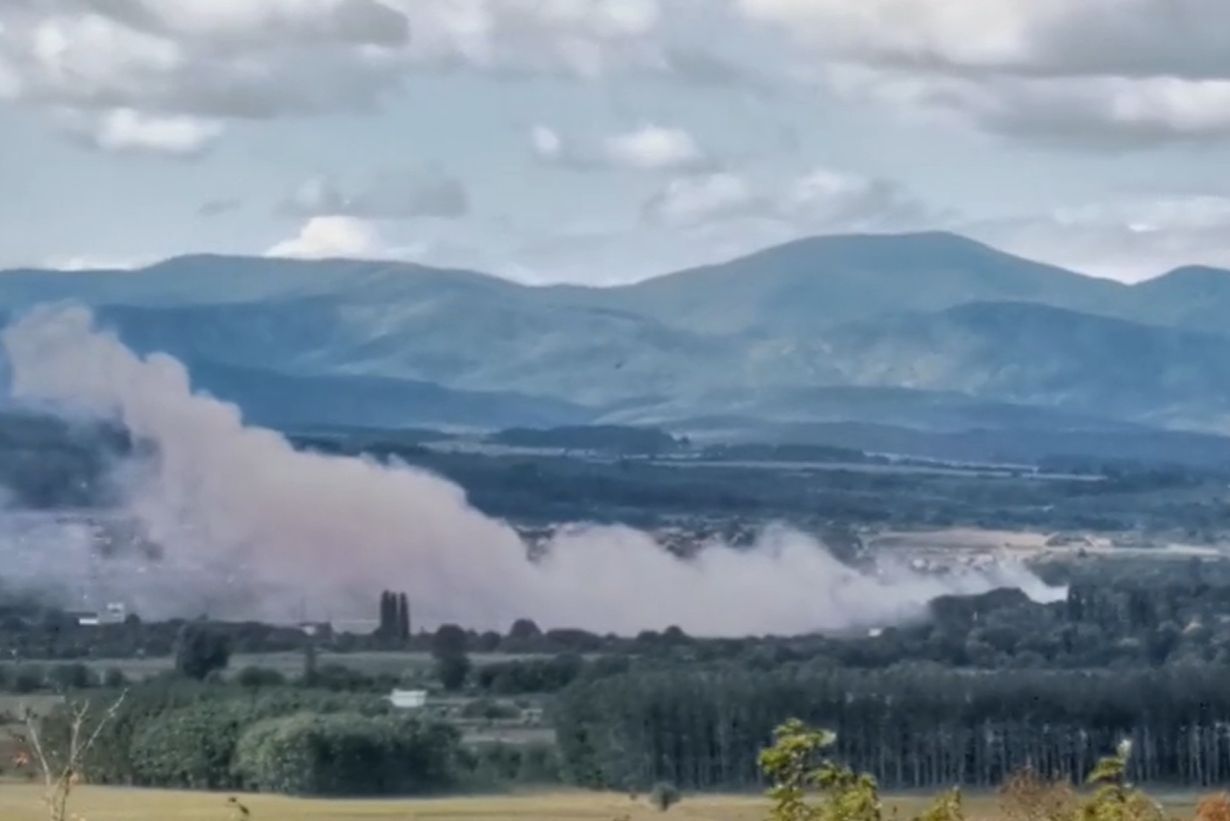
235, 713, 459, 795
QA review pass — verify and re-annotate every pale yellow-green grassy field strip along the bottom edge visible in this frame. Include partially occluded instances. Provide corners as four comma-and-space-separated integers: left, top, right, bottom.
0, 783, 1210, 821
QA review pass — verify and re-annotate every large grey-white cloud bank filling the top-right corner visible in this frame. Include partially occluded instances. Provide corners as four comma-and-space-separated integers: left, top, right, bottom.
736, 0, 1230, 146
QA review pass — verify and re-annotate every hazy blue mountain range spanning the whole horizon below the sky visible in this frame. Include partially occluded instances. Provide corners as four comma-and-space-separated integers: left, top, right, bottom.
7, 233, 1230, 455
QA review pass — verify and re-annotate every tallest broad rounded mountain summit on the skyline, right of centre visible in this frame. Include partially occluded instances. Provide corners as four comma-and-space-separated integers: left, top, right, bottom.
590, 233, 1128, 334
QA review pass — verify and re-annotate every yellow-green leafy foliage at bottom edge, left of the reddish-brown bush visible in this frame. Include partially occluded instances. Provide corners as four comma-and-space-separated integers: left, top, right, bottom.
760, 719, 881, 821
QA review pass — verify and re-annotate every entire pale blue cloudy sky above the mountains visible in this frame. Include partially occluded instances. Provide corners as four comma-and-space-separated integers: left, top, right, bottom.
7, 0, 1230, 284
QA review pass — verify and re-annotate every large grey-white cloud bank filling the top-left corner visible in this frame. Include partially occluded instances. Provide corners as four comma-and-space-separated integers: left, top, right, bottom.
0, 0, 661, 154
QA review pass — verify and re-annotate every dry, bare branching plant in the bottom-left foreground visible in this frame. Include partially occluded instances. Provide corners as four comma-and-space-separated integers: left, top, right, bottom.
8, 691, 127, 821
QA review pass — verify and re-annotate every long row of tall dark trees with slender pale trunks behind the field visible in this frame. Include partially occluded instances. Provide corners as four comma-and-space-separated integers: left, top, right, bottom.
556, 665, 1230, 790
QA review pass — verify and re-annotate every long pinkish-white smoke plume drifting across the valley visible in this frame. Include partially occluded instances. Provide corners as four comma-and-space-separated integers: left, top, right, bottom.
2, 308, 1054, 635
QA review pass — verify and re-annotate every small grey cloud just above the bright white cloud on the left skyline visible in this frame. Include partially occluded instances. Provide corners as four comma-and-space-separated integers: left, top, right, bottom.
282, 171, 470, 219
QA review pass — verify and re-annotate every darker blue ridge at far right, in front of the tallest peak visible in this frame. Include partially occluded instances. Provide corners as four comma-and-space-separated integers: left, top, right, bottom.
819, 303, 1230, 430
